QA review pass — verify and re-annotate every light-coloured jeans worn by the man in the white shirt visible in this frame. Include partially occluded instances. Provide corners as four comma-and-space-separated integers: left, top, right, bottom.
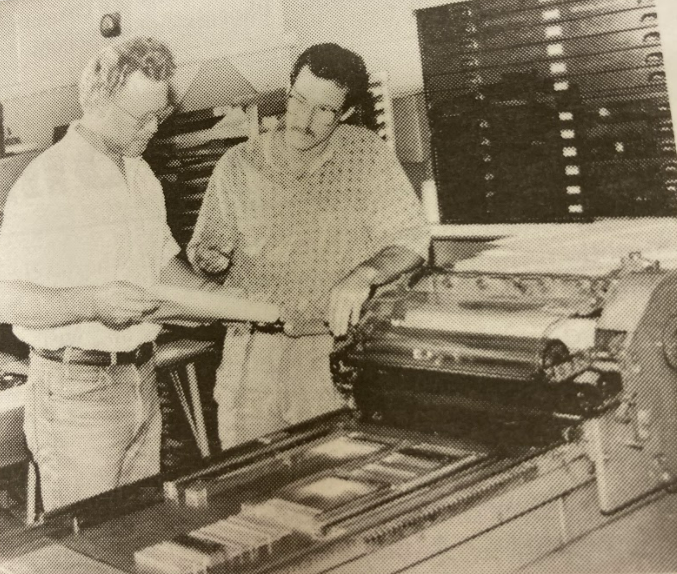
24, 353, 162, 511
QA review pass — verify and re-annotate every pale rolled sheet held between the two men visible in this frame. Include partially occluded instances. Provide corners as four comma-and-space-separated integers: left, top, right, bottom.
149, 285, 280, 323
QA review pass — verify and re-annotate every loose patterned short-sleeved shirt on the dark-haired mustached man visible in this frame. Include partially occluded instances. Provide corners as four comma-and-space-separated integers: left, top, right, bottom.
188, 126, 429, 317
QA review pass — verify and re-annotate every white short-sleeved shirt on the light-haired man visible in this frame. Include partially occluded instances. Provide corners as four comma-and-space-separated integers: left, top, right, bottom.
0, 125, 180, 352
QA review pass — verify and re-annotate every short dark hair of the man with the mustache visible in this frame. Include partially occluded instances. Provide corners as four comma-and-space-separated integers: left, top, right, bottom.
291, 43, 377, 131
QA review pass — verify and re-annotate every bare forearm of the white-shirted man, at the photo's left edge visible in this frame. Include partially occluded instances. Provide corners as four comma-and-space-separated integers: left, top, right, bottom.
0, 281, 96, 329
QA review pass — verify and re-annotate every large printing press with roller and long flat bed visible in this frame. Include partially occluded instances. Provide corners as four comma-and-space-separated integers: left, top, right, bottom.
5, 260, 677, 574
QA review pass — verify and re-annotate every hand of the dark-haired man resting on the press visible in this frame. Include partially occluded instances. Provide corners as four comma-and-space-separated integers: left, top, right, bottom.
327, 266, 377, 337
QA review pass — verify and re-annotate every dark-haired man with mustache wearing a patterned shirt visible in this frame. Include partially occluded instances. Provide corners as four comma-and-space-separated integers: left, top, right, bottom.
188, 44, 429, 448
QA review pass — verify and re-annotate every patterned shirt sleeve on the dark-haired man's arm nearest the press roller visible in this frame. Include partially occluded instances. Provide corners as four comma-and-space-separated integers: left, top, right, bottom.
364, 136, 430, 260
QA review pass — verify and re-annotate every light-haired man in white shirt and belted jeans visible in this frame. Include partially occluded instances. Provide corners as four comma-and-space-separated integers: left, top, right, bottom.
0, 38, 214, 510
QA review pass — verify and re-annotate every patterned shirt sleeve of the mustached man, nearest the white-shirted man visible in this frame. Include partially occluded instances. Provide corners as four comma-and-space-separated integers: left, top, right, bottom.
186, 153, 237, 265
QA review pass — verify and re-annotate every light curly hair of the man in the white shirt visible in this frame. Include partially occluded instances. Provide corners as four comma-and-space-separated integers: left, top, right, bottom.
79, 38, 176, 110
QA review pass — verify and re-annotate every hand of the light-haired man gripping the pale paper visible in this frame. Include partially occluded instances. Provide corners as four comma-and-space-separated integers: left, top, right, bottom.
93, 281, 160, 330
